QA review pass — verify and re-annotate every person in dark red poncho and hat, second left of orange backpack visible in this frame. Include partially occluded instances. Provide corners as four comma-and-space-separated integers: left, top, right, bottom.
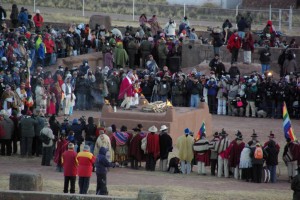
227, 131, 245, 179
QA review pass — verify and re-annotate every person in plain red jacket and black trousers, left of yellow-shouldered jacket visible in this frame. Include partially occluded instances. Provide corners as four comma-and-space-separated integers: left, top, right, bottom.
62, 143, 78, 193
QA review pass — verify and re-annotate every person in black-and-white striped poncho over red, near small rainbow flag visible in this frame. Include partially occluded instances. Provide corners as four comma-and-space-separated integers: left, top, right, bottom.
193, 134, 209, 175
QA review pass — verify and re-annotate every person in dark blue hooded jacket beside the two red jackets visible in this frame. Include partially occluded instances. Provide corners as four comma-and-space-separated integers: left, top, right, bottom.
95, 147, 115, 195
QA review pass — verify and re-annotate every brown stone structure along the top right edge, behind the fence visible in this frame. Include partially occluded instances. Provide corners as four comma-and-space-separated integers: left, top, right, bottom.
241, 0, 297, 9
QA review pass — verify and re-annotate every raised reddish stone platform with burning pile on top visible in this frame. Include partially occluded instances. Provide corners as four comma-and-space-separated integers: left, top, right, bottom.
101, 103, 212, 142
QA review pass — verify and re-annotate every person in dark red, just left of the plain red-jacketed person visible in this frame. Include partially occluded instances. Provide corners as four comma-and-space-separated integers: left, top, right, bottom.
54, 132, 69, 172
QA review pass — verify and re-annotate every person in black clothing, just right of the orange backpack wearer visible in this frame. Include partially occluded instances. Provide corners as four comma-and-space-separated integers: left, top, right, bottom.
265, 140, 279, 183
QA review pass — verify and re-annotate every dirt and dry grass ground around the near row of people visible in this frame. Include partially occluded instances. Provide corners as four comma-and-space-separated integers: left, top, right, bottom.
0, 111, 300, 200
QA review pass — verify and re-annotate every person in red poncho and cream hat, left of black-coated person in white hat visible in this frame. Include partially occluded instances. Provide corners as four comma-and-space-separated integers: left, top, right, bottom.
146, 126, 160, 171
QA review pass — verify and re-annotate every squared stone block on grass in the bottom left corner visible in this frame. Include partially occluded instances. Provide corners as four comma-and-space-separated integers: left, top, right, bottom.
9, 172, 43, 191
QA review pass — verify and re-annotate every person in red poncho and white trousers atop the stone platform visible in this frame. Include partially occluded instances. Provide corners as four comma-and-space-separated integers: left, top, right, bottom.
118, 71, 134, 110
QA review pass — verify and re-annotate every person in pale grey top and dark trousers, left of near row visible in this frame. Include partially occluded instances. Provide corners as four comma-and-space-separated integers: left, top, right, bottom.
40, 120, 54, 166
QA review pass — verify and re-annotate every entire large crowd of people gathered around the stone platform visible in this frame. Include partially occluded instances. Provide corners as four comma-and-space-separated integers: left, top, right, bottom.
0, 4, 300, 198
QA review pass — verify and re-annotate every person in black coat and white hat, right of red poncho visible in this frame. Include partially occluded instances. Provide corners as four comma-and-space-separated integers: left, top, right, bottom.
159, 125, 173, 172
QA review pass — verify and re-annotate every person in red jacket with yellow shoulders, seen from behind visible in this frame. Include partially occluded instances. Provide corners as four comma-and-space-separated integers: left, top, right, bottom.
77, 145, 96, 194
